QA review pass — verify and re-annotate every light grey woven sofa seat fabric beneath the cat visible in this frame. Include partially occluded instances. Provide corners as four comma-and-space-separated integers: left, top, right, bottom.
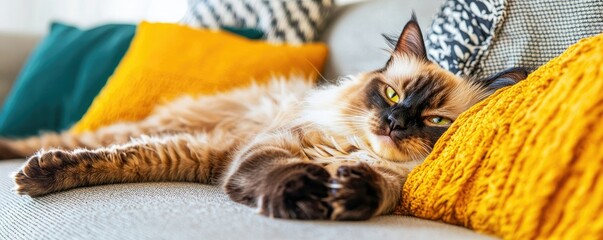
0, 160, 493, 240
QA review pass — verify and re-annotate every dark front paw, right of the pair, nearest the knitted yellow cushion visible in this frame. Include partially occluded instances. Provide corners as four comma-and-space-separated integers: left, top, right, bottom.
330, 163, 382, 220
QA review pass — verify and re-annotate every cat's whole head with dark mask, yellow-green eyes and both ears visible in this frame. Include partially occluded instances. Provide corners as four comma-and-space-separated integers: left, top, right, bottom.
340, 16, 527, 161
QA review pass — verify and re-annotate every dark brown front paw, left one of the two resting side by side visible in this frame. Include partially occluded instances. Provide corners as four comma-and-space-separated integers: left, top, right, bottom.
258, 163, 331, 219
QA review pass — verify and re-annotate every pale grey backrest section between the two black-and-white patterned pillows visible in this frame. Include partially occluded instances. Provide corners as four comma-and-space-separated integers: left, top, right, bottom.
322, 0, 443, 80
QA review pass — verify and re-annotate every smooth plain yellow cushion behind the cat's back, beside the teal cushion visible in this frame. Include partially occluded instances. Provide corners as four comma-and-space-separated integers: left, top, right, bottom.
72, 22, 327, 132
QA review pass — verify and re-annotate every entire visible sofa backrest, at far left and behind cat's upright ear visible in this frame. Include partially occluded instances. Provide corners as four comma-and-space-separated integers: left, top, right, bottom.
0, 0, 442, 106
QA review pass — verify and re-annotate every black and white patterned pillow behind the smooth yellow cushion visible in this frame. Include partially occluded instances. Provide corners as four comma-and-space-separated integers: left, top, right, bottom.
181, 0, 334, 44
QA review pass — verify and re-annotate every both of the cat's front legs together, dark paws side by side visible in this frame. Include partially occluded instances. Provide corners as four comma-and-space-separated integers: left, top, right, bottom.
224, 132, 410, 220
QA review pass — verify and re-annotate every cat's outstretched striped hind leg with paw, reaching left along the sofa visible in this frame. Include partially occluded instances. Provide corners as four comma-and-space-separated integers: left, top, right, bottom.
14, 134, 237, 197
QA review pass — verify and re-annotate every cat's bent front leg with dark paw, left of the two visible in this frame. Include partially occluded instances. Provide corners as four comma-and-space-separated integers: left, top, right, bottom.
223, 133, 332, 219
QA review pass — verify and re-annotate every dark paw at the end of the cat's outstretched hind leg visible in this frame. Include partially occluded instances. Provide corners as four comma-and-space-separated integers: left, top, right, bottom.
13, 150, 70, 197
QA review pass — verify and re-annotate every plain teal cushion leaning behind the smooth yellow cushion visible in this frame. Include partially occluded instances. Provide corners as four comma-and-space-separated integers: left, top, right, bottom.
0, 23, 136, 137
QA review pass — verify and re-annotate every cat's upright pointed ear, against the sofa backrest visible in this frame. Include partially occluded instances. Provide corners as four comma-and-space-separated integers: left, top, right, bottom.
386, 12, 427, 65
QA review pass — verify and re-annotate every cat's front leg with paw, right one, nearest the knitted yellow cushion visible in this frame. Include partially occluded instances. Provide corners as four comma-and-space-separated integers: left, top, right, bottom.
327, 161, 411, 220
